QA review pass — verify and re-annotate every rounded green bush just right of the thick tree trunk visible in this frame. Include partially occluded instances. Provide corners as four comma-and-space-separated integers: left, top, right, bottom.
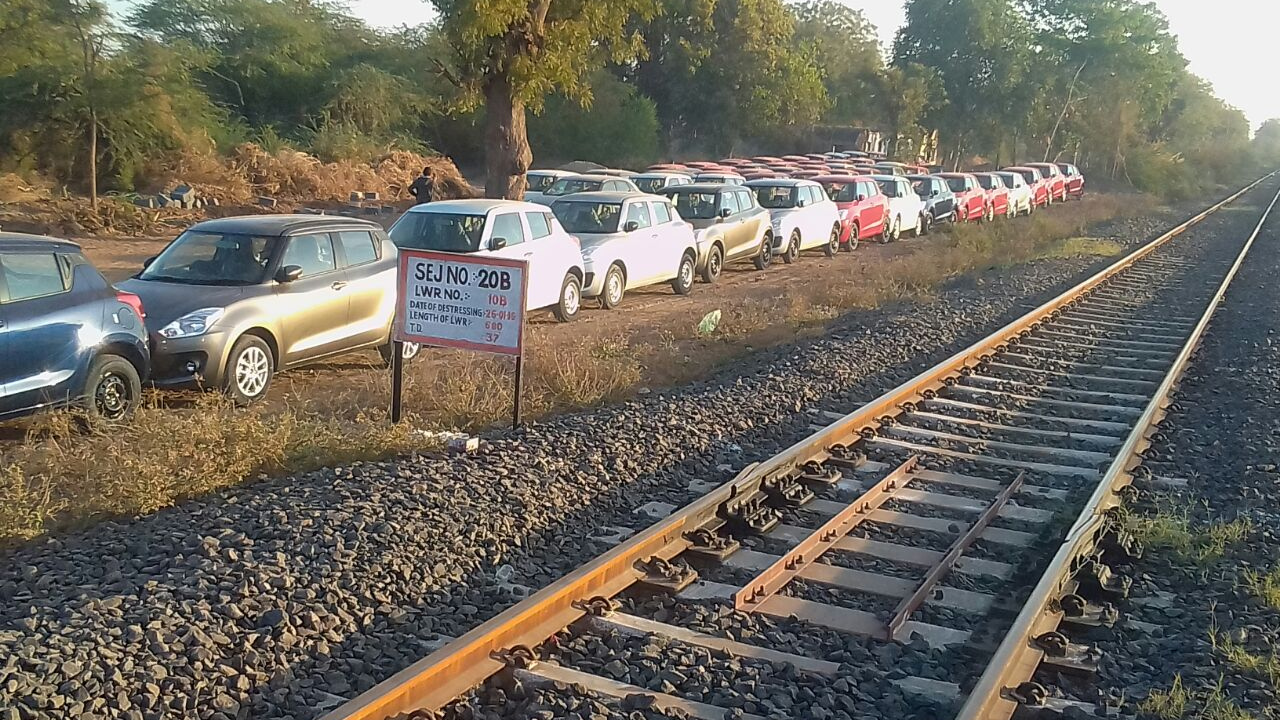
529, 72, 658, 167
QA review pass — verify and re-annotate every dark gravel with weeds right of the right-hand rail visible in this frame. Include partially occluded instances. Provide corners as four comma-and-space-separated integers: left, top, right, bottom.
1050, 188, 1280, 717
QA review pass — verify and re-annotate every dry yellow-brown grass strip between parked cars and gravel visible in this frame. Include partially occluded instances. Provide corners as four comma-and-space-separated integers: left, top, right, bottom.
0, 193, 1138, 543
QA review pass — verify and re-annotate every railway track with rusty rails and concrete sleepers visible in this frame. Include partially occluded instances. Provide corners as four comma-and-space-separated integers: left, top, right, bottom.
325, 176, 1280, 720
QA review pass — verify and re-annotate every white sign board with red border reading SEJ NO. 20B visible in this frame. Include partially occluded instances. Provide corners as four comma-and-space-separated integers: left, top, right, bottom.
396, 250, 529, 355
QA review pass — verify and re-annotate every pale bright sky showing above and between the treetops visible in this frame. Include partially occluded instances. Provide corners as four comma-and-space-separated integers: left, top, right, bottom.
332, 0, 1280, 128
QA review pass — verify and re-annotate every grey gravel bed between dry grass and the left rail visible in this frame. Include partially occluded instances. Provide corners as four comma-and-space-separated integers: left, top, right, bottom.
0, 190, 1259, 720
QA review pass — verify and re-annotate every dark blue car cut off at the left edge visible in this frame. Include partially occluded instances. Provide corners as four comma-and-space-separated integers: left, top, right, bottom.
0, 233, 151, 423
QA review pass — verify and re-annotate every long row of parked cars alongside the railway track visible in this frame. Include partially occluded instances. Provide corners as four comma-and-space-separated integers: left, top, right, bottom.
0, 152, 1084, 421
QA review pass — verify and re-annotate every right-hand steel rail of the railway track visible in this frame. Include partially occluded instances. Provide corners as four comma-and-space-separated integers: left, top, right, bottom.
956, 176, 1280, 720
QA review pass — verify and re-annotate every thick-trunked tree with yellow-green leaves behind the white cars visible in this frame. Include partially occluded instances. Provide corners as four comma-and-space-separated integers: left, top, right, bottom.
431, 0, 659, 197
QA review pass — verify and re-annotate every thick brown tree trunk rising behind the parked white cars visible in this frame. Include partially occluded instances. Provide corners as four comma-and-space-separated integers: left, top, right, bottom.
484, 76, 534, 200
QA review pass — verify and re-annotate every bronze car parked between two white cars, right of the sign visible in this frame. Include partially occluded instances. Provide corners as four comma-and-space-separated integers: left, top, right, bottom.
662, 183, 773, 283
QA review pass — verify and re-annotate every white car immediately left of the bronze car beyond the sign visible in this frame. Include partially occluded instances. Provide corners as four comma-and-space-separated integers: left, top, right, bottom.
552, 190, 698, 304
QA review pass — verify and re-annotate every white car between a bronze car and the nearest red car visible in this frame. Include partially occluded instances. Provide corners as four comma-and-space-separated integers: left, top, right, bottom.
746, 178, 840, 263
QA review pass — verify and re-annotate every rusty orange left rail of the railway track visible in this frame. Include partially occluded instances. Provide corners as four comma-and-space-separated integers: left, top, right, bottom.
323, 173, 1275, 720
